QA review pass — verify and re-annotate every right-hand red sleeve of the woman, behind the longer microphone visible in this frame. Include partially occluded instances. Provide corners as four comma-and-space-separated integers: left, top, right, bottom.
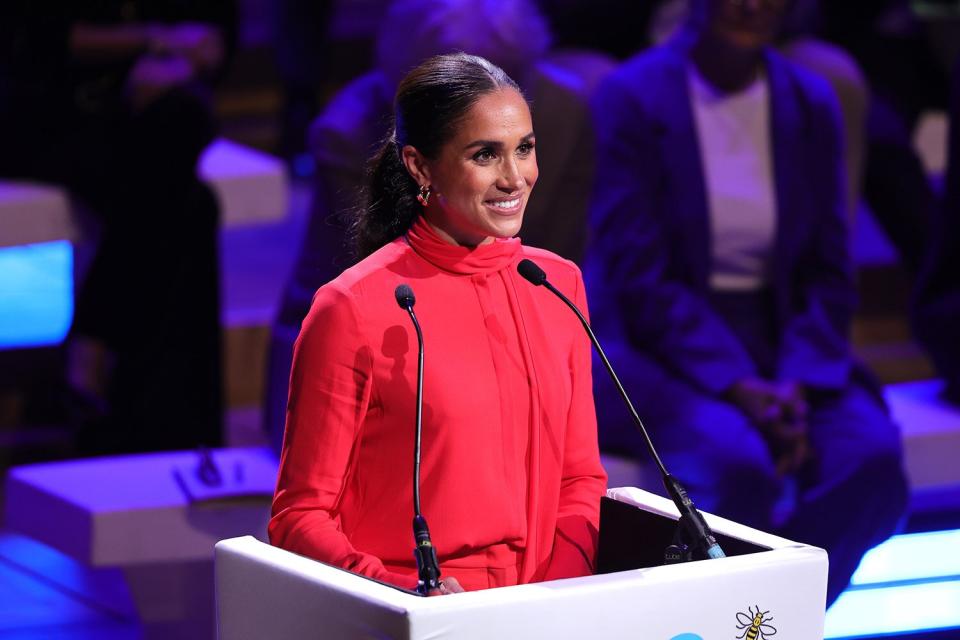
544, 276, 607, 580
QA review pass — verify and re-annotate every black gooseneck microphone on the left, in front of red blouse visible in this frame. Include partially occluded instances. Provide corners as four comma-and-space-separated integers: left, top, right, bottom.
393, 284, 440, 595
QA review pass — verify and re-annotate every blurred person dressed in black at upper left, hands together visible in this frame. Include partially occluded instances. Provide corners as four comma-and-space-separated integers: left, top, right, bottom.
0, 1, 232, 453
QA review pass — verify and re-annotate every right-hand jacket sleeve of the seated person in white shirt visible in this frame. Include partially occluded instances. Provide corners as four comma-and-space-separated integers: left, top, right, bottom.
778, 76, 856, 388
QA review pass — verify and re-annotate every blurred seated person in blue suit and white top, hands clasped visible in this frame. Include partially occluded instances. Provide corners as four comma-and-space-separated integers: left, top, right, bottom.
586, 0, 907, 602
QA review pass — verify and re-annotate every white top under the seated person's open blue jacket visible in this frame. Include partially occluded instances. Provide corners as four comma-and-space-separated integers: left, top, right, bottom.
687, 64, 777, 291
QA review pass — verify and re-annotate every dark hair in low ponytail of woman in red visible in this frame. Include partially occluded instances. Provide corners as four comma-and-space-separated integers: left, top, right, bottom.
352, 53, 520, 258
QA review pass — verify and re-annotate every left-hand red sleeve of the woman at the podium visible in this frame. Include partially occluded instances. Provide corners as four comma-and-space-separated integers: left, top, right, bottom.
269, 286, 415, 587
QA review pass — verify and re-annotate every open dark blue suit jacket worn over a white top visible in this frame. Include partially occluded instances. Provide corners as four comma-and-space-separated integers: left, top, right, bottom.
587, 34, 854, 393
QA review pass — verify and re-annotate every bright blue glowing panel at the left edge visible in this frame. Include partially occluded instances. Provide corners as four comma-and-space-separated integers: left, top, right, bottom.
0, 240, 73, 349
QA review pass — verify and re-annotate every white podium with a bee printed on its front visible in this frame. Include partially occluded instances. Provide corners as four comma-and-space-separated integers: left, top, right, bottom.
216, 488, 827, 640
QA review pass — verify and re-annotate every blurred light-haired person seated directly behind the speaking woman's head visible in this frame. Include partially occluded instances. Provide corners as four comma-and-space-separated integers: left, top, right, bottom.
264, 0, 613, 450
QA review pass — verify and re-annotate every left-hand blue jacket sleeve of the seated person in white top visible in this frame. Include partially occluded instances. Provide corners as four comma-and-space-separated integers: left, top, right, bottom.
588, 73, 755, 393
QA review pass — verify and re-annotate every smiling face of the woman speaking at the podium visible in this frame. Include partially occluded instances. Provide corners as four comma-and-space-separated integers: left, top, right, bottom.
403, 88, 538, 246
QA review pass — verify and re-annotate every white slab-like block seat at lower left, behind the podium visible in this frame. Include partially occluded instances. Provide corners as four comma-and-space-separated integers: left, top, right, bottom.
5, 449, 277, 567
